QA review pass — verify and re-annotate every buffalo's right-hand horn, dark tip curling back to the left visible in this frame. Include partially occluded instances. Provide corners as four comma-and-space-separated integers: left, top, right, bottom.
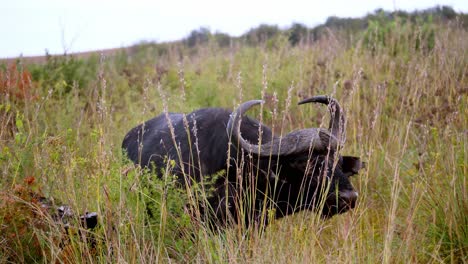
298, 95, 346, 147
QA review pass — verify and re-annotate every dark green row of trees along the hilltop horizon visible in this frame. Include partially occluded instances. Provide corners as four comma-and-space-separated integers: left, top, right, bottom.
182, 6, 468, 47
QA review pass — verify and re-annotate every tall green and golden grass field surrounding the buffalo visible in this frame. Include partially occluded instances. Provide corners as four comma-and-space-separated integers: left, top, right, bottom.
0, 18, 468, 263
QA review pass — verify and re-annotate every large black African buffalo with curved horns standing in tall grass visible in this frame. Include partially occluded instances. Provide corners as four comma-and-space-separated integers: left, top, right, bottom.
122, 96, 363, 225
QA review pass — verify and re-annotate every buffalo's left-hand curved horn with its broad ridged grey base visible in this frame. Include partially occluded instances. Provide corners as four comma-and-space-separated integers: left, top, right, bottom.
227, 100, 337, 157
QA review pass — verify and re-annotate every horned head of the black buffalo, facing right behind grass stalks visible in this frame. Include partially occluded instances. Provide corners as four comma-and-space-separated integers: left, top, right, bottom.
227, 96, 364, 217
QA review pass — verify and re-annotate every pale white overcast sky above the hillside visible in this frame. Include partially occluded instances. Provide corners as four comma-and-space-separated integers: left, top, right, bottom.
0, 0, 468, 58
